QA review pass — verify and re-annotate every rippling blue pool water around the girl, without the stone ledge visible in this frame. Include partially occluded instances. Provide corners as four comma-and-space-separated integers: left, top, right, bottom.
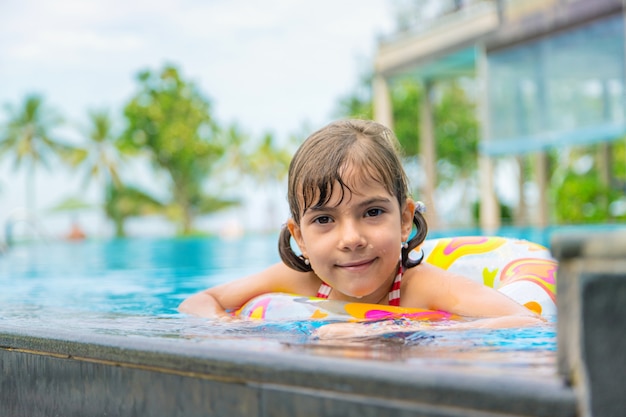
0, 235, 556, 378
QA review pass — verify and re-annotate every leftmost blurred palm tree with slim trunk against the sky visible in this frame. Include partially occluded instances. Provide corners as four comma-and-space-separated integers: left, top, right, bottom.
0, 94, 66, 211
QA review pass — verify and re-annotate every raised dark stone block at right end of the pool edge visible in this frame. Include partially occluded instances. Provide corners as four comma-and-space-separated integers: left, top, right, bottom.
551, 226, 626, 417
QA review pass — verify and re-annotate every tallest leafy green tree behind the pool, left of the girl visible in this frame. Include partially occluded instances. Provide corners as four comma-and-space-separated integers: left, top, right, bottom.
121, 66, 233, 234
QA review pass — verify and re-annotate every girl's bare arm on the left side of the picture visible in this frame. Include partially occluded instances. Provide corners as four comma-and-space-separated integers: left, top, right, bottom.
178, 263, 319, 317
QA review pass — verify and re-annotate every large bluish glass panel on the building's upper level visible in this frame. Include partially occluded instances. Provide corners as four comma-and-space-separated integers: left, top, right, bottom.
481, 15, 626, 154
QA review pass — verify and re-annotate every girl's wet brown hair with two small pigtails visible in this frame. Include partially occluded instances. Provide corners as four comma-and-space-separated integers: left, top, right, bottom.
278, 120, 428, 272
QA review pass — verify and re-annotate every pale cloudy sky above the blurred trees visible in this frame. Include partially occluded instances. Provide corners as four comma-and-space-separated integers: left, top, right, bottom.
0, 0, 394, 237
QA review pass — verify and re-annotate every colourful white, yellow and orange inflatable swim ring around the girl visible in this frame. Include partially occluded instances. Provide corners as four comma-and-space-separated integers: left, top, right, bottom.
235, 236, 557, 321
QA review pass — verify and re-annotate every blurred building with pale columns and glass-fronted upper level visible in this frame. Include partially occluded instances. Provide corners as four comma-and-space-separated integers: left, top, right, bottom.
374, 0, 626, 231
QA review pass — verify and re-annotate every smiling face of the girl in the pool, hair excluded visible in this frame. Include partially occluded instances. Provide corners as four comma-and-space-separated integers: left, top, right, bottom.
288, 172, 415, 303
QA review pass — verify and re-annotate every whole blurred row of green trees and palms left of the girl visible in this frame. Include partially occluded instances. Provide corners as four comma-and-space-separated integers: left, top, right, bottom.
0, 65, 291, 236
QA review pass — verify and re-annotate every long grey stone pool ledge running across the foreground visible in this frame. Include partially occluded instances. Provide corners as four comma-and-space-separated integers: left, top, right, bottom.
0, 324, 576, 417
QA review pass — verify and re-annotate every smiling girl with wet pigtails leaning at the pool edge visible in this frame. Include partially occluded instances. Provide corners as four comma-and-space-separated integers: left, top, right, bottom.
179, 120, 541, 327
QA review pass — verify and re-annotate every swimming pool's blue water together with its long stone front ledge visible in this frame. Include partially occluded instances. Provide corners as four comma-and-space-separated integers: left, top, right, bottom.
0, 235, 575, 417
